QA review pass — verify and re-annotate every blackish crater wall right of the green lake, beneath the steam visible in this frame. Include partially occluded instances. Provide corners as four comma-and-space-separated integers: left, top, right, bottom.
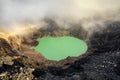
90, 21, 120, 52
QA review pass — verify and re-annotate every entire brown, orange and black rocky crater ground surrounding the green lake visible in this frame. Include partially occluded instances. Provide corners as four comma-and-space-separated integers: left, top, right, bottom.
0, 21, 120, 80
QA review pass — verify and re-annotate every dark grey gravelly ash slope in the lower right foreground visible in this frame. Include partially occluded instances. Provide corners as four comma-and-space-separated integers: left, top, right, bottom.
33, 52, 120, 80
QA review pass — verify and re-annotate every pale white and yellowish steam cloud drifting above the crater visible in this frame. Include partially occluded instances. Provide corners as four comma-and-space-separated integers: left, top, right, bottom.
0, 0, 120, 34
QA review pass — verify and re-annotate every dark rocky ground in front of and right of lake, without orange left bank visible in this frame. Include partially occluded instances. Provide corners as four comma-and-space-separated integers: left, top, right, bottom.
0, 22, 120, 80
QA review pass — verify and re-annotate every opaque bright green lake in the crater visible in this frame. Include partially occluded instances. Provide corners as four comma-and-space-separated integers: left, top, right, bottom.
35, 36, 88, 61
